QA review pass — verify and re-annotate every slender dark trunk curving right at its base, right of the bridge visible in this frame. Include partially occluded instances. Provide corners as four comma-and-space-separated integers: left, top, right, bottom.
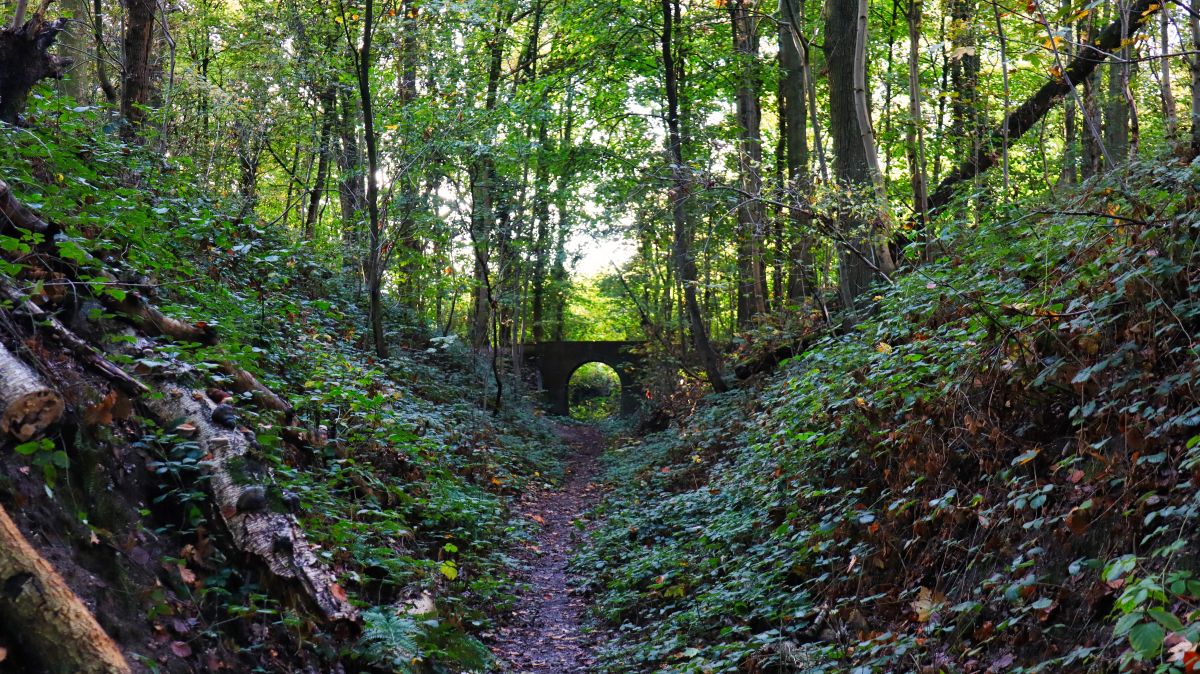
661, 0, 727, 392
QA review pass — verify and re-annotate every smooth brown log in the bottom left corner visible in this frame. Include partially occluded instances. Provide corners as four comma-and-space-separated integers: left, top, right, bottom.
0, 506, 130, 674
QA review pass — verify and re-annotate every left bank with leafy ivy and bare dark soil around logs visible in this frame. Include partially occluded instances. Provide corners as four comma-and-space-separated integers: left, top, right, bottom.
0, 98, 560, 673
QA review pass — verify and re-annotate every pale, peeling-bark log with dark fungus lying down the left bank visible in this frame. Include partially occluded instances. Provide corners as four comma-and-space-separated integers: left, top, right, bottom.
146, 385, 358, 622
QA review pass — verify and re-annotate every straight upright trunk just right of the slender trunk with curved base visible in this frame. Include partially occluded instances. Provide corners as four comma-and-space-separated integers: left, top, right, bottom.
728, 0, 767, 327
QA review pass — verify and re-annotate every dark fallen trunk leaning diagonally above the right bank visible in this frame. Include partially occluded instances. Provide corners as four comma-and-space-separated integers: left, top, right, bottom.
929, 0, 1164, 211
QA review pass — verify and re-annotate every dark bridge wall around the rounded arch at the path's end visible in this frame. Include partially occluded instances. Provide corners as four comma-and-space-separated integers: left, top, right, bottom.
524, 342, 643, 416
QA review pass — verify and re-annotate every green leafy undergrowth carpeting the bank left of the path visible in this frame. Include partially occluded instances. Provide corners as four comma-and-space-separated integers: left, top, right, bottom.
0, 91, 560, 672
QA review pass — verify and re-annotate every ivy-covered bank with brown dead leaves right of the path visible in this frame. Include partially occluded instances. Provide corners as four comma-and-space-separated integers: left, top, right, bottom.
576, 162, 1200, 673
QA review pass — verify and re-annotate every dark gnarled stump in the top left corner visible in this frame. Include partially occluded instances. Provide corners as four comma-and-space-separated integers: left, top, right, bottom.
0, 0, 73, 124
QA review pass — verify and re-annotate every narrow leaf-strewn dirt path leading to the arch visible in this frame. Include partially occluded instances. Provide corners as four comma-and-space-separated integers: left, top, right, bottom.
492, 426, 604, 674
